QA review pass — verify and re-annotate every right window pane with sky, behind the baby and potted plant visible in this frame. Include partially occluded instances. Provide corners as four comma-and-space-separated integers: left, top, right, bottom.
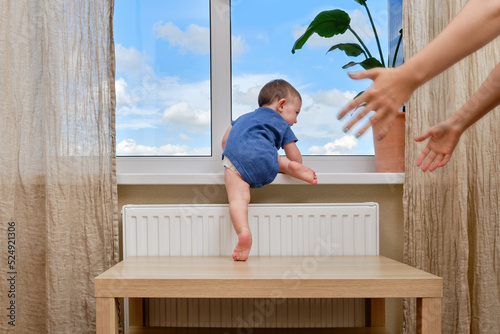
231, 0, 388, 155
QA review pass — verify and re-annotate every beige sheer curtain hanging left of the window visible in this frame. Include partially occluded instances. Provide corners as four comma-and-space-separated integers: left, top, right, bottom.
0, 0, 118, 334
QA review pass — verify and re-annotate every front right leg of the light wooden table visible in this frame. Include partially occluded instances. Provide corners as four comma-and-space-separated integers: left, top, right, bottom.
417, 298, 441, 334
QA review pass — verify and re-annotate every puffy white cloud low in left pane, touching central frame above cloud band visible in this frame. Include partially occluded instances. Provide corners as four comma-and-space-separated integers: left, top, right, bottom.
163, 102, 210, 130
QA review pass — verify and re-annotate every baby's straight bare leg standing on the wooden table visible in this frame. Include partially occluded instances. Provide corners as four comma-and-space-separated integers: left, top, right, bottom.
224, 168, 252, 261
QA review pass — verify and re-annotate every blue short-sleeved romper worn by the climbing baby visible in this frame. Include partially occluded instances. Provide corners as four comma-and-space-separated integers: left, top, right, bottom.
222, 107, 298, 188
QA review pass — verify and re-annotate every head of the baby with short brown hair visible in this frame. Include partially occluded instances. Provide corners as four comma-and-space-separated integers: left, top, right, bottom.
258, 79, 302, 125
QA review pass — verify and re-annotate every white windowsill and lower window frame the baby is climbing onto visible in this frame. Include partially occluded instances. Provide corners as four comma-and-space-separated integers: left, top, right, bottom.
117, 156, 405, 185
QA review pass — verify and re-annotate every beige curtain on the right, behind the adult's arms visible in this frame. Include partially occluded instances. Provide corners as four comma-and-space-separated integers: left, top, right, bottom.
403, 0, 500, 334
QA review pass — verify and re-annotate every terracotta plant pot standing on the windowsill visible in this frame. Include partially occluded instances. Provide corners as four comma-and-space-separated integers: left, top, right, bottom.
373, 112, 405, 173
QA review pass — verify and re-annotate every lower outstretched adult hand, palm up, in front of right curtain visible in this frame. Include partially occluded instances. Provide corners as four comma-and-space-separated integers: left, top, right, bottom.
415, 120, 463, 172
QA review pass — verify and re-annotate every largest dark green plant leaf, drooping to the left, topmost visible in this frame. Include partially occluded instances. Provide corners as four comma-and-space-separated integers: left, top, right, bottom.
292, 9, 351, 53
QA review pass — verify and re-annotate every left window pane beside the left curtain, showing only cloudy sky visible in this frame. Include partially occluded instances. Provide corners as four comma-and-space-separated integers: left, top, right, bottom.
114, 0, 211, 156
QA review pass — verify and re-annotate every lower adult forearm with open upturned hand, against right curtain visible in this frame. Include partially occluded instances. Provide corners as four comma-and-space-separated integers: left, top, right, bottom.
415, 64, 500, 172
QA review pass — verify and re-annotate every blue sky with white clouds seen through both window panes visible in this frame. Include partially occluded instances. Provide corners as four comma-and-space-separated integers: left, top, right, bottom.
114, 0, 398, 155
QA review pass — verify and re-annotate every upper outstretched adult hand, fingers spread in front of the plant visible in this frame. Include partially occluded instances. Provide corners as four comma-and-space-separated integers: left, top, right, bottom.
338, 68, 417, 140
